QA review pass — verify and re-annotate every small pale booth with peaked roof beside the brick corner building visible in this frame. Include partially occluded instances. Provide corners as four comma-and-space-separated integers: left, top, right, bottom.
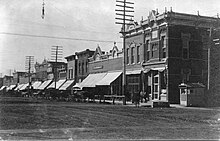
179, 83, 205, 106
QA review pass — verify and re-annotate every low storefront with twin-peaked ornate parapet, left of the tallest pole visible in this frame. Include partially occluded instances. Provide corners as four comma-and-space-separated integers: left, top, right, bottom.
89, 44, 123, 95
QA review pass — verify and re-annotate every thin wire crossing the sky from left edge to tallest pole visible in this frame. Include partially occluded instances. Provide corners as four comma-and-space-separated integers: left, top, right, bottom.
0, 32, 122, 43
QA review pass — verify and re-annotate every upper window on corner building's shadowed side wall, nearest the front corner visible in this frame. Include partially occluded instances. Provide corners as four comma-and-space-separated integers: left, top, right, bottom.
181, 33, 190, 59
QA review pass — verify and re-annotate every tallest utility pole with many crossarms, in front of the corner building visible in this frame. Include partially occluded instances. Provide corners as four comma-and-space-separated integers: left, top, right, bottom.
115, 0, 134, 104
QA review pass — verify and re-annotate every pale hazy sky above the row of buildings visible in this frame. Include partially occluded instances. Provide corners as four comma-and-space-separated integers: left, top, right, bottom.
0, 0, 220, 77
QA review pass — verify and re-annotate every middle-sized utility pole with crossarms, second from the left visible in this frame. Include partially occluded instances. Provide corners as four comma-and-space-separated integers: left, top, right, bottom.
51, 46, 63, 89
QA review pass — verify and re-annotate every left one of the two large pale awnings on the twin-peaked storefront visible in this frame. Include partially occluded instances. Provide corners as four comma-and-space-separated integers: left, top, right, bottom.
80, 73, 107, 88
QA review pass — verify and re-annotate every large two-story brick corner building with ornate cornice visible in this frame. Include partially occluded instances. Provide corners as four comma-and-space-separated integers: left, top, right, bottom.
125, 10, 220, 103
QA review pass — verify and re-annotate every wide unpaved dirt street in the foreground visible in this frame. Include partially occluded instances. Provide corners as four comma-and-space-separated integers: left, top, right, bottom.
0, 98, 220, 140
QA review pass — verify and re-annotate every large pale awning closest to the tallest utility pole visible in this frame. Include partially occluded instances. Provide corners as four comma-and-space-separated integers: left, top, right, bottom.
96, 72, 122, 86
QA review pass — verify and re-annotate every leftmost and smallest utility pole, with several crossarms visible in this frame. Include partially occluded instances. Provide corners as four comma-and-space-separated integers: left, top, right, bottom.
25, 56, 34, 95
